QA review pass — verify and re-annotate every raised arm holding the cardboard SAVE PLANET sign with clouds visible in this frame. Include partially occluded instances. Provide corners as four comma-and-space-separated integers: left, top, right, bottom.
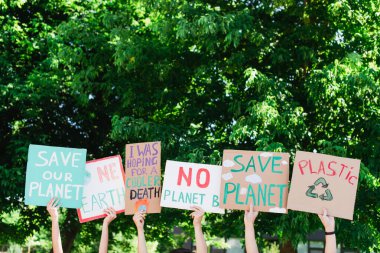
244, 204, 259, 253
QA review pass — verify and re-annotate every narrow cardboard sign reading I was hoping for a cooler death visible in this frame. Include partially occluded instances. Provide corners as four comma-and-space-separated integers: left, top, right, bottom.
125, 142, 161, 215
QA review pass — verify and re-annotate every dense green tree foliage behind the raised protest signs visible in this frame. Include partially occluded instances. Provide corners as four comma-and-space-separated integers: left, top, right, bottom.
0, 0, 380, 252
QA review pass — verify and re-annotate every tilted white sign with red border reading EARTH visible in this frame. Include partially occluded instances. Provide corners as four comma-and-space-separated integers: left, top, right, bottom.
77, 155, 125, 223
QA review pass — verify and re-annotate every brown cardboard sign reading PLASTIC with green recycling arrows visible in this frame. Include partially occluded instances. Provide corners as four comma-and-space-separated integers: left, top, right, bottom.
288, 151, 360, 220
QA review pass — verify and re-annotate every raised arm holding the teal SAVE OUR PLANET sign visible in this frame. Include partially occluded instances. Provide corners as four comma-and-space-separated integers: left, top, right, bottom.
46, 198, 63, 253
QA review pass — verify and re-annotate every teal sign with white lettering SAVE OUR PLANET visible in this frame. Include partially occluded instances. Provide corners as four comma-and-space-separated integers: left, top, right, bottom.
25, 144, 87, 208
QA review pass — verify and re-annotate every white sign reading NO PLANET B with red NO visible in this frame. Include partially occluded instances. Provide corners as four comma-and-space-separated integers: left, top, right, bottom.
161, 160, 224, 213
